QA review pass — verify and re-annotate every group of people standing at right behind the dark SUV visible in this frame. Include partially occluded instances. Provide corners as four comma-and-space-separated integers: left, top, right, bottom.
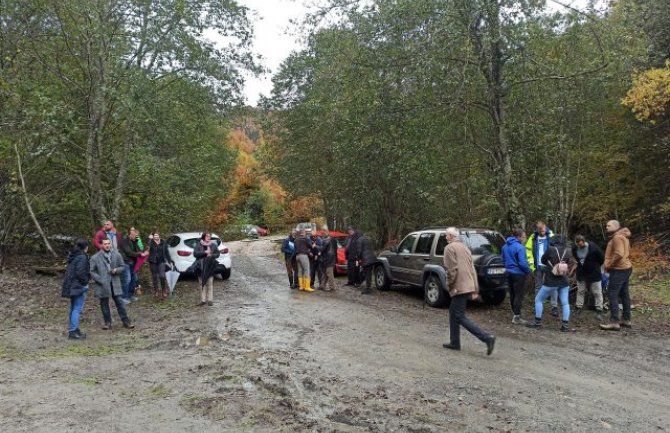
502, 220, 633, 332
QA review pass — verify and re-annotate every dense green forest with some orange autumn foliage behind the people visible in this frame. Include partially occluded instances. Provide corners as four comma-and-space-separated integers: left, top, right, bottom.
0, 0, 670, 257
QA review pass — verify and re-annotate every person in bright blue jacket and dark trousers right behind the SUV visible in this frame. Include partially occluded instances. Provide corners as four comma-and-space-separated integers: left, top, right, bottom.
502, 228, 531, 325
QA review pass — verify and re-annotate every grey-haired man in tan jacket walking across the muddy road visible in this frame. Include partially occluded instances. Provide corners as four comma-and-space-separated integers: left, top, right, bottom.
442, 227, 496, 355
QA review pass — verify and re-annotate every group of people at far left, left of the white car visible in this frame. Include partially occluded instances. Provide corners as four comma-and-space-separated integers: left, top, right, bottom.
61, 220, 184, 340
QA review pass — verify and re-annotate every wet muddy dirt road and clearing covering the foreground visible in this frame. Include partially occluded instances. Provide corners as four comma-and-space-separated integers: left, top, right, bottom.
0, 240, 670, 432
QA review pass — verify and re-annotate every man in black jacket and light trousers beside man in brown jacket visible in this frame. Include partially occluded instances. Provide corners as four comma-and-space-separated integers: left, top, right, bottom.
572, 235, 605, 320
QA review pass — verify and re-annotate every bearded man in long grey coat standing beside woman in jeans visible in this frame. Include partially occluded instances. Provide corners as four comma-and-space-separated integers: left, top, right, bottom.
91, 239, 135, 329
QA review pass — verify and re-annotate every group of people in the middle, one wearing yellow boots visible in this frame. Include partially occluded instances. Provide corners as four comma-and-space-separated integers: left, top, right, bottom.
281, 227, 377, 294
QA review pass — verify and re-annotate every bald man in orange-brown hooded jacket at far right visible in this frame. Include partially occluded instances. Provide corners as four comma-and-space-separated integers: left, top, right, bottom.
600, 220, 633, 331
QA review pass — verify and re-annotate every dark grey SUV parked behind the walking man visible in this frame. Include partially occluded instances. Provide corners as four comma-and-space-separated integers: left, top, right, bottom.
374, 227, 507, 307
